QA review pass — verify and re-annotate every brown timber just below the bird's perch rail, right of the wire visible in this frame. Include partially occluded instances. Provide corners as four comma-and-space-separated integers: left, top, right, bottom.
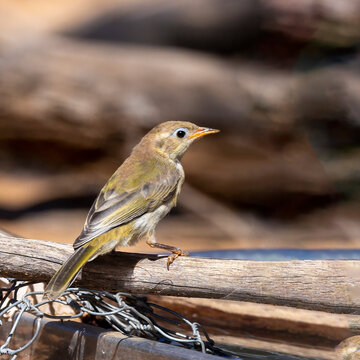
148, 295, 360, 352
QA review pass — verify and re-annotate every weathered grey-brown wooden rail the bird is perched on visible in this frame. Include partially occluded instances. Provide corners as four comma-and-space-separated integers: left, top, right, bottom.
0, 236, 360, 313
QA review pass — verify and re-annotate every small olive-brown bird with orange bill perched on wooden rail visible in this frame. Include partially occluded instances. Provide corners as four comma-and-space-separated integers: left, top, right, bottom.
44, 121, 219, 300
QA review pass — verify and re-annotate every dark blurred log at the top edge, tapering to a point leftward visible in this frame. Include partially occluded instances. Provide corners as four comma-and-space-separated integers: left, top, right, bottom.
67, 0, 264, 53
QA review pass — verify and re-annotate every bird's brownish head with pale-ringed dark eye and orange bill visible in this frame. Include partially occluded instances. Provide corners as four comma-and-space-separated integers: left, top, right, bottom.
146, 121, 220, 160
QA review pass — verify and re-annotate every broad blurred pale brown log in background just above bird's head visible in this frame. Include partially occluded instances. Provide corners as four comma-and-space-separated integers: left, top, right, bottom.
0, 23, 359, 142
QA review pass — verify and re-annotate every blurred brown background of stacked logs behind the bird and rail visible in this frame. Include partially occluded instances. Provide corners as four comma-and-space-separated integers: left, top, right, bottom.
0, 0, 360, 252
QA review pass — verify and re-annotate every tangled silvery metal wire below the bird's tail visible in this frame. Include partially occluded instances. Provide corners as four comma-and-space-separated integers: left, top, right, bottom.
0, 279, 239, 360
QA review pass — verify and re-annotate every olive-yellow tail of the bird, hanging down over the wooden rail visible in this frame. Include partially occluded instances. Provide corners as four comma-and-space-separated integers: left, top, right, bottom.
44, 243, 99, 300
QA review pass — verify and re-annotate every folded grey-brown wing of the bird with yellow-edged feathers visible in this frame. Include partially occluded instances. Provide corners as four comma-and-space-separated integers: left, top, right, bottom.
73, 161, 181, 249
